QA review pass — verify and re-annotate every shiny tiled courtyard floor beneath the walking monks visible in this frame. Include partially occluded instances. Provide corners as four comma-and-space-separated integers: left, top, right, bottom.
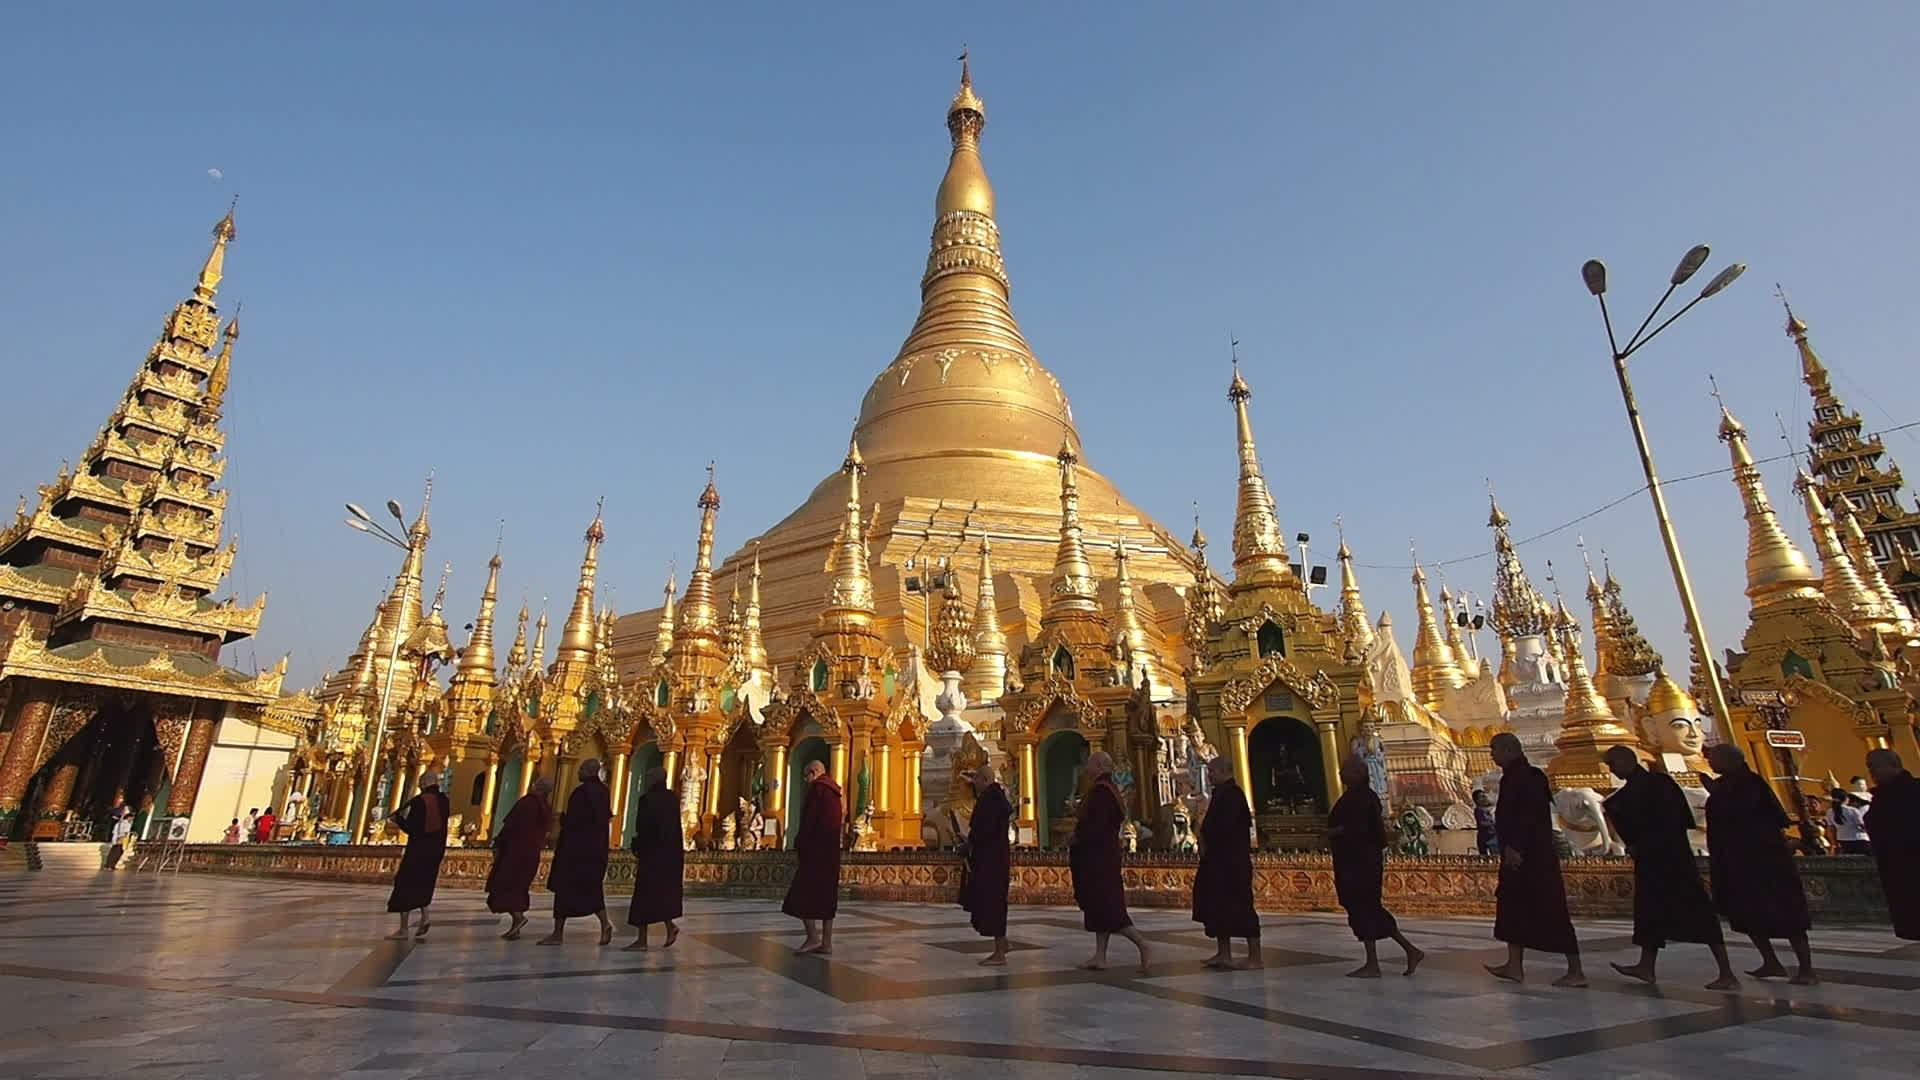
0, 869, 1920, 1080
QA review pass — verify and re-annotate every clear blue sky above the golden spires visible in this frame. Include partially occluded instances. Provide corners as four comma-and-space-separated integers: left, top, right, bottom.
0, 2, 1920, 682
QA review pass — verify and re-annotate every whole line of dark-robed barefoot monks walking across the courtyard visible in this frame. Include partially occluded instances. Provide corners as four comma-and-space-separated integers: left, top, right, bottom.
366, 734, 1920, 990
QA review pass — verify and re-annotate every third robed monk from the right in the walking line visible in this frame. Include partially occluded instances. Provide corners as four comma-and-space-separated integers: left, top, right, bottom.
1603, 746, 1740, 990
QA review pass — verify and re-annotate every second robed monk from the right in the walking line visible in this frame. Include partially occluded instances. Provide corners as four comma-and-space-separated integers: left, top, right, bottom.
1707, 742, 1820, 986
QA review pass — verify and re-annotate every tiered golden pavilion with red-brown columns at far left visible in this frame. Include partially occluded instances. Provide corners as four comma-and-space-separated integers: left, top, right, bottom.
0, 211, 284, 832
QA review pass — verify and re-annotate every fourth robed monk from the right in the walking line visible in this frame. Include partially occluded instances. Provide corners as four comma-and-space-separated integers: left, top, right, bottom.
1486, 732, 1586, 986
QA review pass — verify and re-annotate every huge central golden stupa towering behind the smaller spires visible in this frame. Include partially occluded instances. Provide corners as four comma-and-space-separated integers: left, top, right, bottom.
614, 65, 1192, 675
